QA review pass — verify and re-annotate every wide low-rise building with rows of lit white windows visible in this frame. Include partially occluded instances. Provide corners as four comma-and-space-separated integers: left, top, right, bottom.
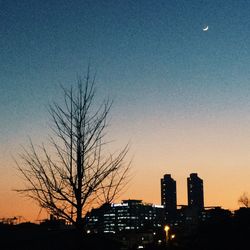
86, 200, 164, 233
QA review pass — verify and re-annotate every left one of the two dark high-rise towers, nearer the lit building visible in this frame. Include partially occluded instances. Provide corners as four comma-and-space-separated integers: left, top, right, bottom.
161, 174, 176, 223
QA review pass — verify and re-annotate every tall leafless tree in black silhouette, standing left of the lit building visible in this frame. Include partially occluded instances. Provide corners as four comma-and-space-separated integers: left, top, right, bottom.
17, 71, 130, 229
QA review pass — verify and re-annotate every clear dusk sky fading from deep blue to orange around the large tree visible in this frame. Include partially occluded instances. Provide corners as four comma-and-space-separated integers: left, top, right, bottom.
0, 0, 250, 220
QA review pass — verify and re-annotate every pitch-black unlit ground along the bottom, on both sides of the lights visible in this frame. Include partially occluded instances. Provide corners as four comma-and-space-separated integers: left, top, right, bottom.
0, 209, 250, 250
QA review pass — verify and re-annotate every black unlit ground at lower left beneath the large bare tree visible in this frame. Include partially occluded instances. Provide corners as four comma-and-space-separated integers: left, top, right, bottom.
0, 223, 120, 250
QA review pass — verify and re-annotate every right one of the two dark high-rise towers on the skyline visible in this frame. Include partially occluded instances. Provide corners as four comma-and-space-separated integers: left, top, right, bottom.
187, 173, 204, 211
